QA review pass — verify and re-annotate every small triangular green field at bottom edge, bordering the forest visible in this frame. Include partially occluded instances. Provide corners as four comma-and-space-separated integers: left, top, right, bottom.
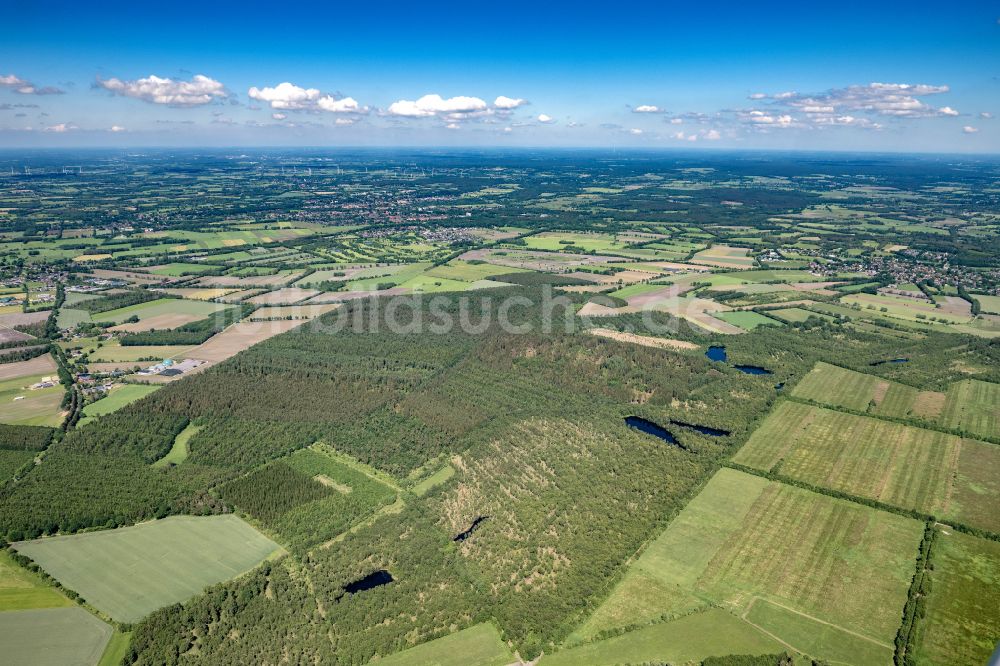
375, 622, 517, 666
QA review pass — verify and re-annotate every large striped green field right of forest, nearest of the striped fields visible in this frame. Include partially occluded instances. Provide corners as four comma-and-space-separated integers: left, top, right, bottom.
574, 469, 923, 661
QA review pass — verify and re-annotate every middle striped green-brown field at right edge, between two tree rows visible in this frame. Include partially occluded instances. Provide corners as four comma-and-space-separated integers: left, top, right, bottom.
733, 401, 1000, 531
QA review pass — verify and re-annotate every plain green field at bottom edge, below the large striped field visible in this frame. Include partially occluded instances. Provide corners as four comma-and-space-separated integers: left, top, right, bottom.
539, 608, 787, 666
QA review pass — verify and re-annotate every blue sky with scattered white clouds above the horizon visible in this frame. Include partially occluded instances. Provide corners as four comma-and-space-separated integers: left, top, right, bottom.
0, 0, 1000, 153
